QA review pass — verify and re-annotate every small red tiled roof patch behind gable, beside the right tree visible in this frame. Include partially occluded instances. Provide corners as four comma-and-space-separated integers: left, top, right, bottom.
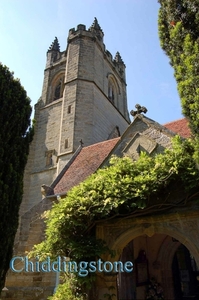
164, 118, 191, 138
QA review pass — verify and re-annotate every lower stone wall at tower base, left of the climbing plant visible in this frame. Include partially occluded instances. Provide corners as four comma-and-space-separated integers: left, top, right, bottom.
1, 199, 56, 300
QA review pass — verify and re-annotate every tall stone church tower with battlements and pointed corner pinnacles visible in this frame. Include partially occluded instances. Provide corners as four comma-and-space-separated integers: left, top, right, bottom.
21, 18, 130, 214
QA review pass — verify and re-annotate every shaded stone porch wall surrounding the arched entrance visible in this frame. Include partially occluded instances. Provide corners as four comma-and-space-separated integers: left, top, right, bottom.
96, 207, 199, 300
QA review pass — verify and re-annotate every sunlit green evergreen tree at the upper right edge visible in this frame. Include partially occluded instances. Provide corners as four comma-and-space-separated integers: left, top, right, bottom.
159, 0, 199, 140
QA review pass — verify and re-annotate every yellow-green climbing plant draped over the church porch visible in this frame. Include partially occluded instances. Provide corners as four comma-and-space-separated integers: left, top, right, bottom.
31, 137, 199, 299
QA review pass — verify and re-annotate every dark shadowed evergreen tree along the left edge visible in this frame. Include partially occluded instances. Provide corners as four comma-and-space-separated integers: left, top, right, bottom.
0, 64, 33, 291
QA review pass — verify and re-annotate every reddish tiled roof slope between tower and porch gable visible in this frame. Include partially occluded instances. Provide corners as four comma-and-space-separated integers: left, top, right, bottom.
54, 138, 120, 194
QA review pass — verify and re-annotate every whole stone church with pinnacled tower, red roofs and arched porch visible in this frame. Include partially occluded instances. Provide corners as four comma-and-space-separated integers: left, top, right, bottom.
1, 18, 199, 300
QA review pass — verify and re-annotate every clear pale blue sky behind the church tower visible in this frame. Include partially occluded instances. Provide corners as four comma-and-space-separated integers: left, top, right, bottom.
0, 0, 182, 124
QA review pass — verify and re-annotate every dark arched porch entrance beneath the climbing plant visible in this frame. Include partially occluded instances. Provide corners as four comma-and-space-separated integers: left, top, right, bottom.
117, 234, 199, 300
